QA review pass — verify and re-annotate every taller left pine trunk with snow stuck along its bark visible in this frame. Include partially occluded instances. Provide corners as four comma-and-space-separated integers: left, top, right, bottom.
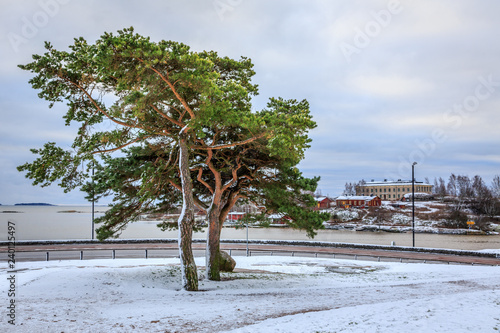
178, 133, 198, 291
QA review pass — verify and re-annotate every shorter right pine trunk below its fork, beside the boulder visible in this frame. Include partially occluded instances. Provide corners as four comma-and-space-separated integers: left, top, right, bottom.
206, 203, 221, 281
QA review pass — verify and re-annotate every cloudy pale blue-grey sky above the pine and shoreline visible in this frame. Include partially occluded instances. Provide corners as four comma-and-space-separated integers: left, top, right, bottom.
0, 0, 500, 204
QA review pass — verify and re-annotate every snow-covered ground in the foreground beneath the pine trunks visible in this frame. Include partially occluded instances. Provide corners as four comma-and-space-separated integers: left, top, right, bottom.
0, 257, 500, 333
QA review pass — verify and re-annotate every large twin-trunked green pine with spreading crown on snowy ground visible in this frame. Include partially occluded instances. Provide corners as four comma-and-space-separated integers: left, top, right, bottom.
18, 28, 327, 290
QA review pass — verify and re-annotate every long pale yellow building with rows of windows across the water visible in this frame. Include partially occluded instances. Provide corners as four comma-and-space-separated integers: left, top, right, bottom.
356, 179, 432, 201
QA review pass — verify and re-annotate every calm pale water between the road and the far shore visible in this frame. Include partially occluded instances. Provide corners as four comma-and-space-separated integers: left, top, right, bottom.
0, 206, 500, 250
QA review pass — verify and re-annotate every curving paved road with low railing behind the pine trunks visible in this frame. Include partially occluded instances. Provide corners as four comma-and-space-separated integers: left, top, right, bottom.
0, 243, 500, 265
